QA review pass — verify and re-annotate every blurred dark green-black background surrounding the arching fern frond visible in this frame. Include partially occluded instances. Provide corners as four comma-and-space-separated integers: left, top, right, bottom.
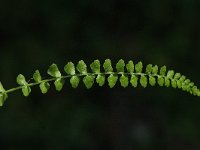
0, 0, 200, 150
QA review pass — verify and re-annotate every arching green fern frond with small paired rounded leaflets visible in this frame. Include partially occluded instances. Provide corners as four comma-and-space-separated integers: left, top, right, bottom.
0, 59, 200, 106
